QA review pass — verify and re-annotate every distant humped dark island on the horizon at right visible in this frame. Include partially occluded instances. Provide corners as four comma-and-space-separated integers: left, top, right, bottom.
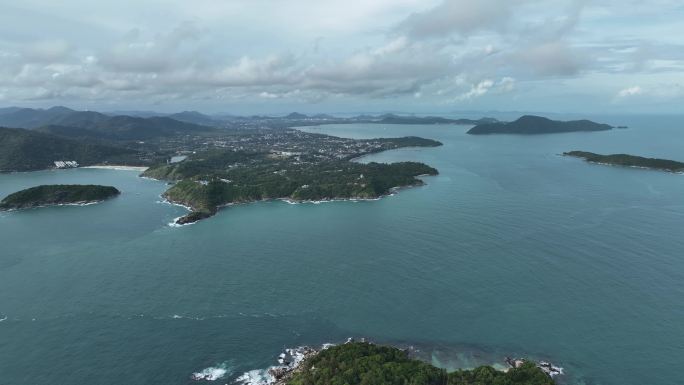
468, 115, 613, 135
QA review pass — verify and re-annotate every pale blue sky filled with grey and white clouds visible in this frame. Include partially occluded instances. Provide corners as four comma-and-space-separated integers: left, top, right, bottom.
0, 0, 684, 114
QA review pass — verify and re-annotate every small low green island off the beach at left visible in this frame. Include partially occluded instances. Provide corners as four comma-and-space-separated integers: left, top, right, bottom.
0, 185, 121, 210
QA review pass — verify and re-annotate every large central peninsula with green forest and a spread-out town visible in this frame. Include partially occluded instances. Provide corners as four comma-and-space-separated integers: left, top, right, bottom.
142, 130, 441, 225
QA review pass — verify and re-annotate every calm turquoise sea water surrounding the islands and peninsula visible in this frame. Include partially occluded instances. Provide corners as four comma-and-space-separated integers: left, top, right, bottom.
0, 118, 684, 385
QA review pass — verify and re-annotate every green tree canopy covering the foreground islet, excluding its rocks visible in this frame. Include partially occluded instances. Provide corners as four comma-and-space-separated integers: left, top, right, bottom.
287, 343, 554, 385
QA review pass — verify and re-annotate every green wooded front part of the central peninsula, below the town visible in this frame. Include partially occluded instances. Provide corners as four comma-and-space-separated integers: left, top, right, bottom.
152, 151, 437, 224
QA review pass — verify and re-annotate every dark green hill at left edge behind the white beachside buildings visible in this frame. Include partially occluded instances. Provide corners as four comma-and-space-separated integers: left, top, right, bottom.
0, 127, 139, 172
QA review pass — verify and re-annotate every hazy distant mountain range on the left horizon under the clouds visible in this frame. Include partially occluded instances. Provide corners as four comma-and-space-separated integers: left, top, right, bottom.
0, 107, 214, 140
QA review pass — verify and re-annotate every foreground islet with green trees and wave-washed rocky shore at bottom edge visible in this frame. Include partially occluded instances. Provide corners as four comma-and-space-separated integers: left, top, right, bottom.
227, 339, 562, 385
